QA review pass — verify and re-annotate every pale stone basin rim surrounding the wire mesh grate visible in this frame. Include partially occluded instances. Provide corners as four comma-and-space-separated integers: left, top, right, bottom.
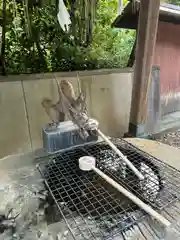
0, 139, 180, 240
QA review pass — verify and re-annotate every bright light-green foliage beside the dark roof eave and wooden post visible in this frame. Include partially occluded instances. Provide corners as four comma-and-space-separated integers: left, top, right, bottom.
90, 0, 135, 68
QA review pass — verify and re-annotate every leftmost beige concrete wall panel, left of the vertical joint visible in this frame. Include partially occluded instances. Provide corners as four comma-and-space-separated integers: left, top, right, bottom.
0, 81, 31, 157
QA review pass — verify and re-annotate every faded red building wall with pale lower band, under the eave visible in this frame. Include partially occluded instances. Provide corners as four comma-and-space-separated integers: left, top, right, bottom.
153, 22, 180, 115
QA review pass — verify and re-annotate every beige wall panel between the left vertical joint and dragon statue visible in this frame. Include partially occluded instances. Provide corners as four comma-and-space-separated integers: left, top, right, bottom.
23, 79, 57, 149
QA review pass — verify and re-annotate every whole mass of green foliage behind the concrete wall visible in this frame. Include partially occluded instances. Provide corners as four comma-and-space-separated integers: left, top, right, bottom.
6, 0, 135, 74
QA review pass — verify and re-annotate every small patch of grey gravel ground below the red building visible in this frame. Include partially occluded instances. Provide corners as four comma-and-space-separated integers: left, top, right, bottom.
156, 129, 180, 148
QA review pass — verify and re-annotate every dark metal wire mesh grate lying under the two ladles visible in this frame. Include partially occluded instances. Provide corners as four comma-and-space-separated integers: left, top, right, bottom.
39, 140, 180, 240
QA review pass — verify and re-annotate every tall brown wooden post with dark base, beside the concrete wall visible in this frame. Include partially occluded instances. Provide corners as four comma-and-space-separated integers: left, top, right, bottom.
129, 0, 160, 136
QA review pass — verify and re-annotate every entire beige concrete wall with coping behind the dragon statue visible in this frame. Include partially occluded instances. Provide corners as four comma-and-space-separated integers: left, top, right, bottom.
0, 69, 132, 157
